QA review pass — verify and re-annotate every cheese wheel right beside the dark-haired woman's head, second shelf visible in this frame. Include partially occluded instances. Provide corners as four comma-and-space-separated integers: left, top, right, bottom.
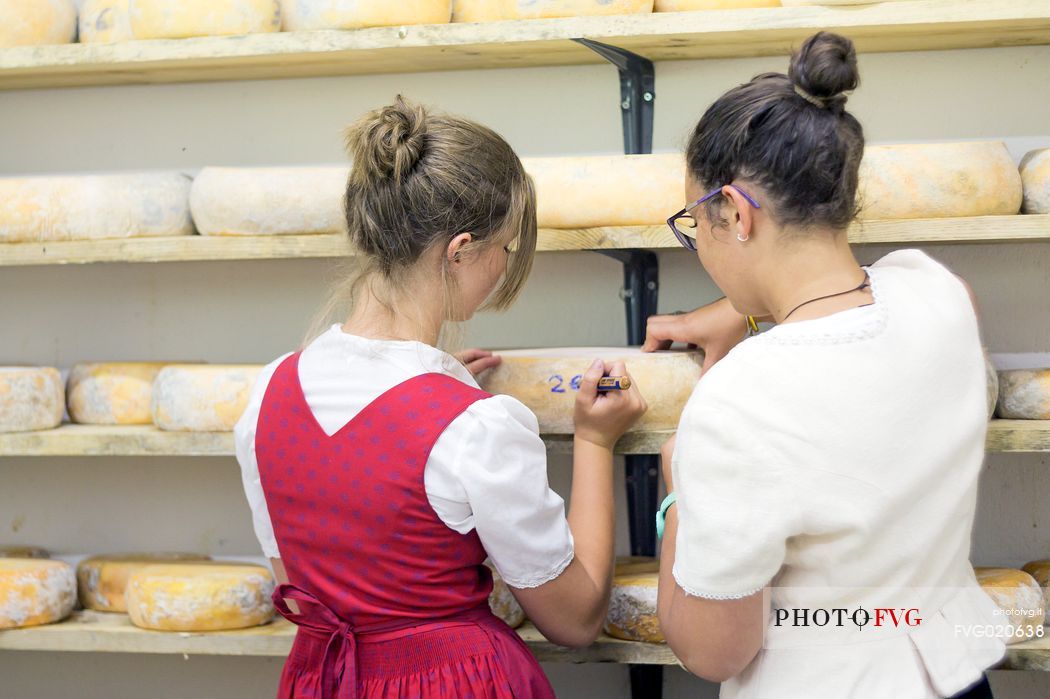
858, 141, 1022, 219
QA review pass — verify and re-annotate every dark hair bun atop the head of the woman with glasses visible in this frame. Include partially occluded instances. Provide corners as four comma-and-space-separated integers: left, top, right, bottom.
788, 31, 860, 108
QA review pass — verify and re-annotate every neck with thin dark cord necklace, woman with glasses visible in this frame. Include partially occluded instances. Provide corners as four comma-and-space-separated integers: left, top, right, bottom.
763, 231, 870, 323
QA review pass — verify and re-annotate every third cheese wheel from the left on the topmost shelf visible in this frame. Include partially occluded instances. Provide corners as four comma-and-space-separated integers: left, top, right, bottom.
129, 0, 280, 39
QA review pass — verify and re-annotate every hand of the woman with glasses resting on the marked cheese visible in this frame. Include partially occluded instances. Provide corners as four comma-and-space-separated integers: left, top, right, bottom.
642, 298, 748, 373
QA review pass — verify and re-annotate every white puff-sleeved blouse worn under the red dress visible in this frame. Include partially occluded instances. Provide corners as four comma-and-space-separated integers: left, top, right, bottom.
234, 325, 573, 588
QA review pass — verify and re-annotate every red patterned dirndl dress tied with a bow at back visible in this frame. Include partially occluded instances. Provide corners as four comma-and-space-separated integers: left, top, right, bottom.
255, 354, 554, 699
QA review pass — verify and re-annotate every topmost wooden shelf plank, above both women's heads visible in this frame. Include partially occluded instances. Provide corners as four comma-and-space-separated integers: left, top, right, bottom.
0, 0, 1050, 89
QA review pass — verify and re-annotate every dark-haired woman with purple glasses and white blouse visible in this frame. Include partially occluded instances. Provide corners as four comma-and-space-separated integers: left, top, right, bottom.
646, 33, 1004, 699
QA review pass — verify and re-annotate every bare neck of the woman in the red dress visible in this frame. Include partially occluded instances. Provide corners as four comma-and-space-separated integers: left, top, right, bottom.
342, 274, 444, 346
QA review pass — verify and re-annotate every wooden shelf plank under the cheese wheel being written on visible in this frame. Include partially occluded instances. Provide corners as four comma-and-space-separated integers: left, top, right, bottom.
0, 420, 1050, 457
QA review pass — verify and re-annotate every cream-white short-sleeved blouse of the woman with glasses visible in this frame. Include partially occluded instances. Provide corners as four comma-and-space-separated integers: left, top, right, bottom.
672, 250, 1009, 699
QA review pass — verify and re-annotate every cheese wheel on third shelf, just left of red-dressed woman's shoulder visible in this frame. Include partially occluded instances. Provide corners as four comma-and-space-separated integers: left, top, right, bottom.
150, 364, 263, 432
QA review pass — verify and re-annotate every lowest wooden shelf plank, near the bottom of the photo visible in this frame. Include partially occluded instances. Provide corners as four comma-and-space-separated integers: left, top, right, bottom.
0, 611, 1050, 672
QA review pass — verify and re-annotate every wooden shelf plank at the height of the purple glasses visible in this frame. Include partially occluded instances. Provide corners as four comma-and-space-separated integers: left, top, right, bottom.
0, 214, 1050, 267
